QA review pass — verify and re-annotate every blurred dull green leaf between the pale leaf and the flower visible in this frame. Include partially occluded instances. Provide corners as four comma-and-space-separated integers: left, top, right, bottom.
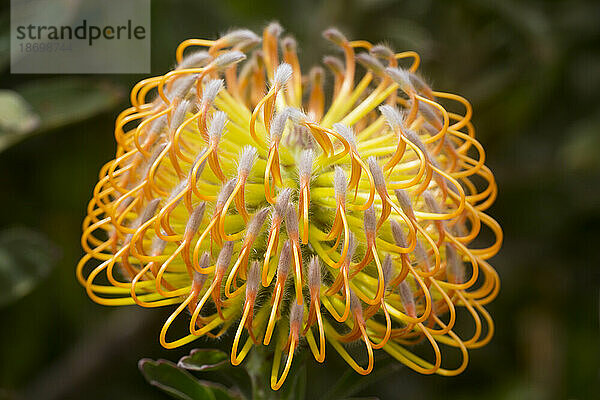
17, 78, 122, 130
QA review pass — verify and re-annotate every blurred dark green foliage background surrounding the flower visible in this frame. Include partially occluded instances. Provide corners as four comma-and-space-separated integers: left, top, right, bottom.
0, 0, 600, 400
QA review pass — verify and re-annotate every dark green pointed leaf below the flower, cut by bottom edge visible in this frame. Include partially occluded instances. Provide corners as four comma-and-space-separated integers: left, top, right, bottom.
138, 359, 226, 400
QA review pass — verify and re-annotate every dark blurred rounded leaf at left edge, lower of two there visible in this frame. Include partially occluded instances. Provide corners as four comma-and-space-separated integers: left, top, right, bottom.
0, 228, 59, 306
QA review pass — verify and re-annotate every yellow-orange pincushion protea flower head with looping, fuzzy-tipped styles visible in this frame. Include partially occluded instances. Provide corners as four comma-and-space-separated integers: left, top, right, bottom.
77, 24, 502, 390
